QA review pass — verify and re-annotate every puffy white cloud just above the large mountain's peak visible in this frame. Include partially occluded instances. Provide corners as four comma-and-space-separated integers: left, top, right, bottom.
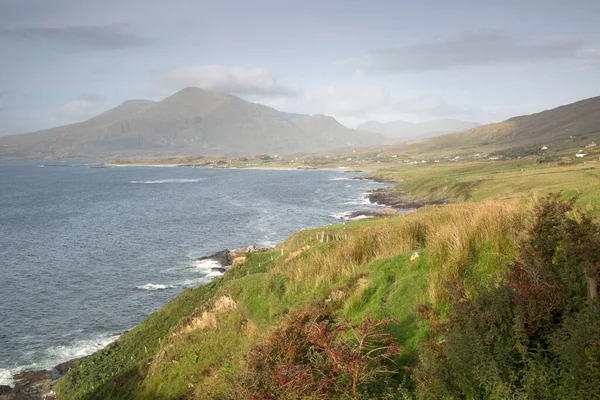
161, 65, 300, 97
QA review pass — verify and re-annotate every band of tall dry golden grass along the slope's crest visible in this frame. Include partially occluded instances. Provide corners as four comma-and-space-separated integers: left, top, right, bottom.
276, 201, 528, 303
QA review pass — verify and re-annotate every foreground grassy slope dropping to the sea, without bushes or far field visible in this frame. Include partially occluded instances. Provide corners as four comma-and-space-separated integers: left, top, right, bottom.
58, 202, 525, 399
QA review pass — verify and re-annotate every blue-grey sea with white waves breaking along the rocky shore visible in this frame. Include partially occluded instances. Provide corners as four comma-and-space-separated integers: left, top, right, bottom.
0, 161, 390, 384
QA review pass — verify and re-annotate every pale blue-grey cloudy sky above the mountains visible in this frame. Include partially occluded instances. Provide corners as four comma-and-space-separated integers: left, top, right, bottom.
0, 0, 600, 135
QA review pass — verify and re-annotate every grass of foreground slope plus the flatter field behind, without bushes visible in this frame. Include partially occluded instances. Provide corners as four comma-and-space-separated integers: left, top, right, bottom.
57, 148, 600, 400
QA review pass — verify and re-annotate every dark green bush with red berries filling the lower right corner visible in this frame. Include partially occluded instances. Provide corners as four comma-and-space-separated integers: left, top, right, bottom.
416, 195, 600, 399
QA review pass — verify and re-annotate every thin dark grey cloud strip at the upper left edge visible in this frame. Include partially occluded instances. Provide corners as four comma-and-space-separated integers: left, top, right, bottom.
0, 26, 148, 50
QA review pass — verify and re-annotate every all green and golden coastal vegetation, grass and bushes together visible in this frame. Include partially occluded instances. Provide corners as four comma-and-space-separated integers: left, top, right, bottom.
57, 145, 600, 400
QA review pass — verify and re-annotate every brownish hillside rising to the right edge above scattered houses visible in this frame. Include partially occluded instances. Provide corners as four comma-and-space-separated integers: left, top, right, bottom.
412, 96, 600, 155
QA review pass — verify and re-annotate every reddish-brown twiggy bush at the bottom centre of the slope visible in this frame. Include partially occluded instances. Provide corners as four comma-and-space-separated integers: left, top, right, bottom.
238, 308, 399, 400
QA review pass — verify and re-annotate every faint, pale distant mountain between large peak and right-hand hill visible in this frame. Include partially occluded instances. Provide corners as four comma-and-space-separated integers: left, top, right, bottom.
356, 119, 479, 141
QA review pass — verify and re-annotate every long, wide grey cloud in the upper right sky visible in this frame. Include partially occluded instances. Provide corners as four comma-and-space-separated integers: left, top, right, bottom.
344, 31, 598, 74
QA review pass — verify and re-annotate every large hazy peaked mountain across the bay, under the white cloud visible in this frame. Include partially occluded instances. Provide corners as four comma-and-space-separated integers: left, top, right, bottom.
0, 88, 385, 158
